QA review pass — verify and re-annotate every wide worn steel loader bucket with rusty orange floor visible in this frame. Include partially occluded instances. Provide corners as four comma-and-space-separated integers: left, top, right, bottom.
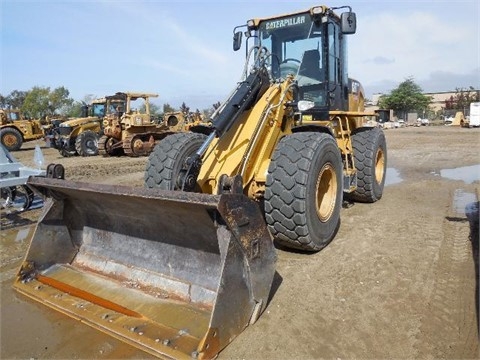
14, 177, 276, 359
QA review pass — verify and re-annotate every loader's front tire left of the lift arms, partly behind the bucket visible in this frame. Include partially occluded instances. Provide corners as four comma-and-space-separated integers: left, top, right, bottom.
144, 133, 207, 190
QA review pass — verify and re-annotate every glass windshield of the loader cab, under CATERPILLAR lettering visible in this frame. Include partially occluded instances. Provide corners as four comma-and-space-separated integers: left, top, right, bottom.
257, 14, 326, 106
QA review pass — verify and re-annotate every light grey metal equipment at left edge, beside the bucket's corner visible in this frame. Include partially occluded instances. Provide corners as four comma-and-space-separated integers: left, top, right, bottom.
0, 144, 46, 211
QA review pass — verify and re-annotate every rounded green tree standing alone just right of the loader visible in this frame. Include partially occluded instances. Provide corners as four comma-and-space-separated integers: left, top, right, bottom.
379, 78, 432, 118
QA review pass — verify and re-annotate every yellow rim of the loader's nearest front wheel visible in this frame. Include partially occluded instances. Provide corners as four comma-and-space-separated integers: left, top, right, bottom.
316, 164, 337, 222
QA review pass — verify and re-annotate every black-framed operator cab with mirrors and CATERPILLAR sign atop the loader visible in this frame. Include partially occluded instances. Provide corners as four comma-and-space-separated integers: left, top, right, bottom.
234, 6, 356, 114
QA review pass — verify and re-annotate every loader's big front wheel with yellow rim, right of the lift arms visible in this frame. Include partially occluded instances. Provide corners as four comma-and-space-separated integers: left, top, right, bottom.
265, 132, 343, 251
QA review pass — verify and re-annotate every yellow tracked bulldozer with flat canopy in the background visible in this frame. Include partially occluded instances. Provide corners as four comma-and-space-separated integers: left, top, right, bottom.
98, 92, 172, 157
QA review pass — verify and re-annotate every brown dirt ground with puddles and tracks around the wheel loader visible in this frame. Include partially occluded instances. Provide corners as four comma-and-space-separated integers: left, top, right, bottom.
0, 126, 480, 359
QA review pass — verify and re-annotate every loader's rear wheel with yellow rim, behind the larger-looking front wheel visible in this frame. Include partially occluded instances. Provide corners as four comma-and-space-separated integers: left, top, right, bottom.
346, 128, 387, 203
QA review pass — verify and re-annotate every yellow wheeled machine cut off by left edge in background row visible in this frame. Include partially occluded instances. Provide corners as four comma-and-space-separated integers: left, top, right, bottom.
0, 109, 44, 151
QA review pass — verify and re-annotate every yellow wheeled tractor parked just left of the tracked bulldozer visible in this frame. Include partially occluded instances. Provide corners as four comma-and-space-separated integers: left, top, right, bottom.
45, 98, 125, 157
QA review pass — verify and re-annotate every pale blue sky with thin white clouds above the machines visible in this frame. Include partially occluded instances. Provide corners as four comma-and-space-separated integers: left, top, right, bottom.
0, 0, 480, 110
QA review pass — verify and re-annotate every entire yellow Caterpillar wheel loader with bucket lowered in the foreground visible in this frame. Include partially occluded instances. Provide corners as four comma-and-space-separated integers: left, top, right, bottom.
14, 6, 387, 359
